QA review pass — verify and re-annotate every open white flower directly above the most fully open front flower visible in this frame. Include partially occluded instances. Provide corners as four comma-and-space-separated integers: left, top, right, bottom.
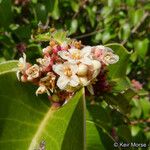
58, 46, 91, 65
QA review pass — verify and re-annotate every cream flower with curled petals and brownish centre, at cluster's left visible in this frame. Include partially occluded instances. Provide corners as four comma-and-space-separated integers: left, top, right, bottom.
26, 64, 40, 81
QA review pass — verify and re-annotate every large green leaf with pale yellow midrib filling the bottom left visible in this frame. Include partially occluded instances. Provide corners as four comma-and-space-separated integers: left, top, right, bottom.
0, 63, 85, 150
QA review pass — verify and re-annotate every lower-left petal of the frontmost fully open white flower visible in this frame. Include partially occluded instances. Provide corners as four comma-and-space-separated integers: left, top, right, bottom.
57, 76, 69, 90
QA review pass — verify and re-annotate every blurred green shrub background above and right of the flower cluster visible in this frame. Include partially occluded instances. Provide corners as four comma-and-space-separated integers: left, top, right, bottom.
0, 0, 150, 145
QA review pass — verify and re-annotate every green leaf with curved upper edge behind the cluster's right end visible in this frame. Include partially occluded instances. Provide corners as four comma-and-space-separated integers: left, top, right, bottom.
105, 43, 131, 91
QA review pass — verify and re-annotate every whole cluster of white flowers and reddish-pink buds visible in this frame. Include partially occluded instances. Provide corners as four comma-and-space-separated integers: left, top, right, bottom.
17, 33, 119, 104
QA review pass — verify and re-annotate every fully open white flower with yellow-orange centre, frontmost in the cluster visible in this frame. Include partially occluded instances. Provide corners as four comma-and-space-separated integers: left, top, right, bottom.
53, 62, 80, 89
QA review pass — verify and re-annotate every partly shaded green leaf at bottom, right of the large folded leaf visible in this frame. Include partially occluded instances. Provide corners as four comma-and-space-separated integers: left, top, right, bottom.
86, 105, 118, 150
